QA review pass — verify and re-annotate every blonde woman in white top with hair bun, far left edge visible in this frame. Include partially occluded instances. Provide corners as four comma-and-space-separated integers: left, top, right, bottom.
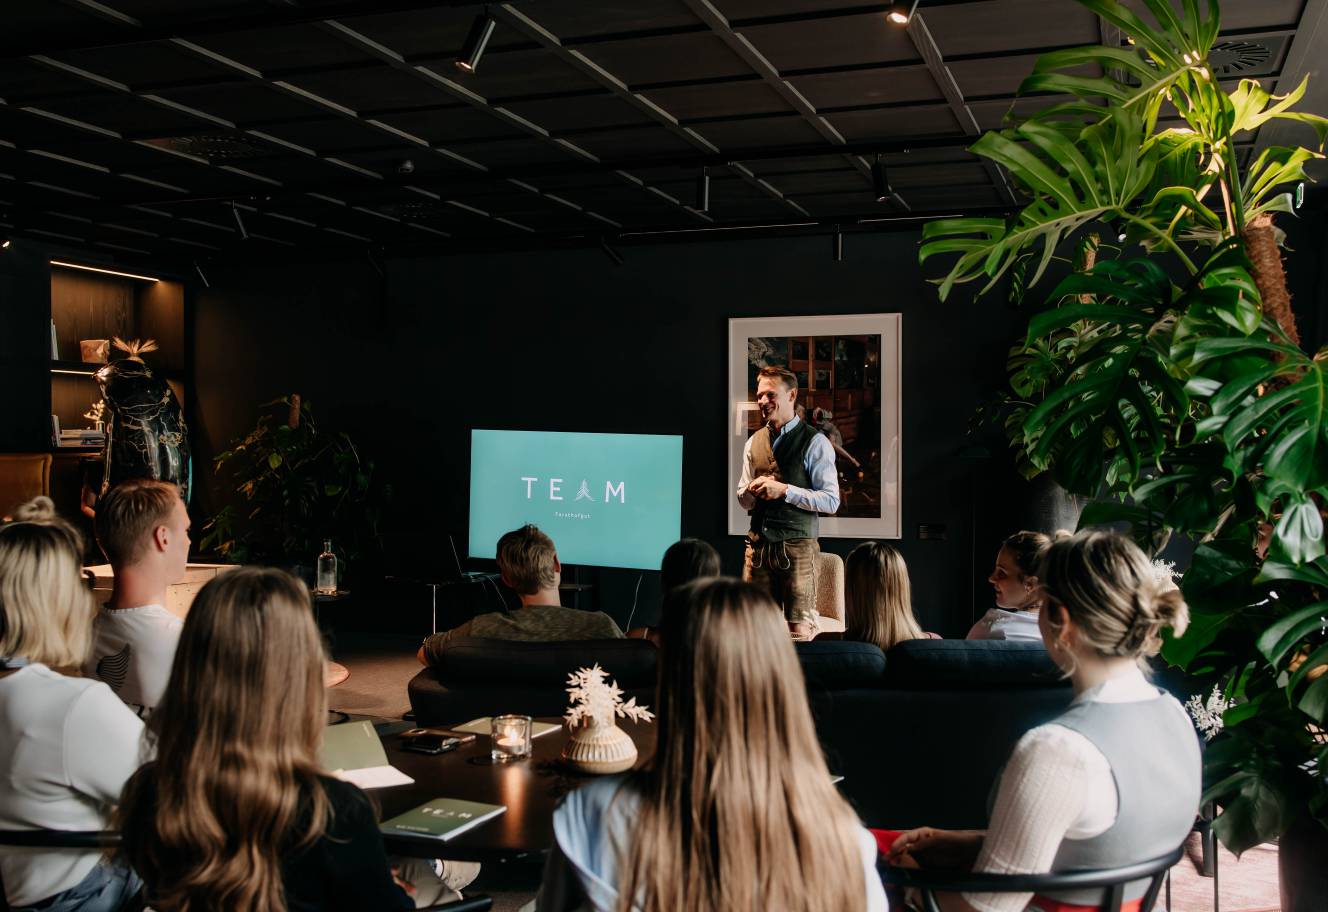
0, 498, 143, 912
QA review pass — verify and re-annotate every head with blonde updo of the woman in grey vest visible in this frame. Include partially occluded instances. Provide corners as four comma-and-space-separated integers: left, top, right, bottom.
1037, 530, 1190, 661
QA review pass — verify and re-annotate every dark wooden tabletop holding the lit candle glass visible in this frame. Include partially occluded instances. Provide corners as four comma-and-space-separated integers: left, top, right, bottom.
372, 718, 655, 862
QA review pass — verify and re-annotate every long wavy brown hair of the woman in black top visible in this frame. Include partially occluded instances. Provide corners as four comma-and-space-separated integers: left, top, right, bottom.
118, 567, 328, 912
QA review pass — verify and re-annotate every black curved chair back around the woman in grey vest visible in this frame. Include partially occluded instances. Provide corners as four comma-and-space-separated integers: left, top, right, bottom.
880, 847, 1185, 912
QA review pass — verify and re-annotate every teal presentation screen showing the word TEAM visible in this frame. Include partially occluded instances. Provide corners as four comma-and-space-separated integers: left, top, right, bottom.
470, 430, 683, 570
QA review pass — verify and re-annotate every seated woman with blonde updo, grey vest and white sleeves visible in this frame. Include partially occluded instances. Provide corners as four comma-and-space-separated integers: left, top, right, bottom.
890, 532, 1201, 912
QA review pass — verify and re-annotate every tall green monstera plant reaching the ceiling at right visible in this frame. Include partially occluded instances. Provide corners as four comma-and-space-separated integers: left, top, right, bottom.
920, 0, 1328, 852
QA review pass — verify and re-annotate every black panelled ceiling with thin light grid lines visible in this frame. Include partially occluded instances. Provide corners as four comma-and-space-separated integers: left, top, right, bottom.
0, 0, 1328, 250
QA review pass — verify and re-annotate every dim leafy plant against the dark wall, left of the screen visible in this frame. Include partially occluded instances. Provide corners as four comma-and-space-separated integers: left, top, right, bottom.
201, 394, 390, 584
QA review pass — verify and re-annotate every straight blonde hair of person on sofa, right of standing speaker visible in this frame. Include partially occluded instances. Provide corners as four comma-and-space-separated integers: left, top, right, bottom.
843, 542, 922, 649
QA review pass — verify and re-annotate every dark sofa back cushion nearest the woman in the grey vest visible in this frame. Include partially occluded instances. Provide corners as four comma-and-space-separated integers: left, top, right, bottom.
886, 640, 1069, 690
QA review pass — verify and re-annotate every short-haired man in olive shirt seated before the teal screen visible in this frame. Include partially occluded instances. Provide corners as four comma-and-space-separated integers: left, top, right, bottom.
420, 526, 623, 665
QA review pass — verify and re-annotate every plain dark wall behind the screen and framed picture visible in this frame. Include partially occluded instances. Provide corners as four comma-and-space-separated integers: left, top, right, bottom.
194, 232, 1021, 636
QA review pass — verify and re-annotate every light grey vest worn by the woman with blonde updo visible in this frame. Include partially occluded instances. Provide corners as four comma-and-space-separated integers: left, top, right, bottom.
1019, 693, 1203, 905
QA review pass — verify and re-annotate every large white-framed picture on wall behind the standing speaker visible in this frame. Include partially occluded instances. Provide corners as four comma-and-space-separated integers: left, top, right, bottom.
725, 313, 903, 539
